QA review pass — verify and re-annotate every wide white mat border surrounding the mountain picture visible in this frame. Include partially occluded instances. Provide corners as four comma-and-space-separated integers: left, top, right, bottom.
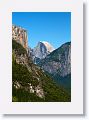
0, 0, 83, 114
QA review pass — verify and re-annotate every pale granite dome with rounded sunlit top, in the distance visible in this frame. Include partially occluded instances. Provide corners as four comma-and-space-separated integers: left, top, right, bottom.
31, 41, 54, 63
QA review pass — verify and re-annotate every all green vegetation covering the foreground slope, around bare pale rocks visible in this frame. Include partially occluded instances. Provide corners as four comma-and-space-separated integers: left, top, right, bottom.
12, 40, 71, 102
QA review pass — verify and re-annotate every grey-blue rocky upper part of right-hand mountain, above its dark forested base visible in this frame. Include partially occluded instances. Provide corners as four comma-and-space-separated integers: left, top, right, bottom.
39, 42, 71, 77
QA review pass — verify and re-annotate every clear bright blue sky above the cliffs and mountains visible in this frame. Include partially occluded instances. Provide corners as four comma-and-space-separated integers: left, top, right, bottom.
12, 12, 71, 49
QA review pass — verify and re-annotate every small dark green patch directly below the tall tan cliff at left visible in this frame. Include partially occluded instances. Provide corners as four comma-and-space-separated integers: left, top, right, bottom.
12, 40, 27, 55
